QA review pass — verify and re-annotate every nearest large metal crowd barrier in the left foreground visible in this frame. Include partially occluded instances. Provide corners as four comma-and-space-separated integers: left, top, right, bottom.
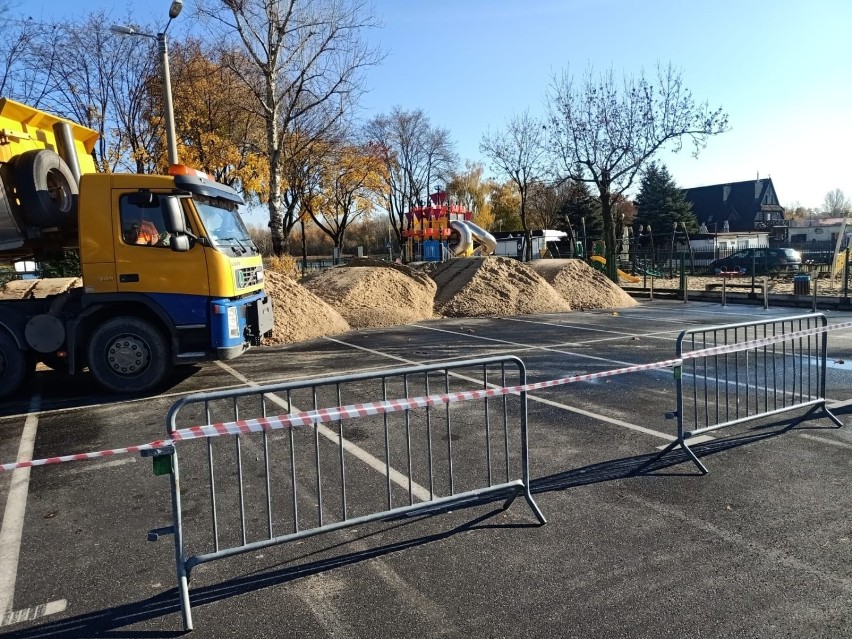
154, 357, 546, 630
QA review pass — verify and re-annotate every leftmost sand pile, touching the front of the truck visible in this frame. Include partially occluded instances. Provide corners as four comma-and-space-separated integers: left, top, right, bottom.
265, 271, 350, 344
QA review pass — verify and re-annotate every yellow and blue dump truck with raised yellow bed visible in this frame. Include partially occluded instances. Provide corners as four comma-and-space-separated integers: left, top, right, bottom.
0, 99, 273, 397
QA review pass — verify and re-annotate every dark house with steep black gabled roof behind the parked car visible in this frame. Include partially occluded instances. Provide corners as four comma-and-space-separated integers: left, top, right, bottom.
683, 178, 788, 242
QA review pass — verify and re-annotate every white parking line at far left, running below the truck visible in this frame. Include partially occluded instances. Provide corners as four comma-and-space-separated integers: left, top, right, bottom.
0, 393, 41, 615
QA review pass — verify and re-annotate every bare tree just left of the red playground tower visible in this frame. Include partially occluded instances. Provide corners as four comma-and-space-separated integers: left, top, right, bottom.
366, 106, 457, 250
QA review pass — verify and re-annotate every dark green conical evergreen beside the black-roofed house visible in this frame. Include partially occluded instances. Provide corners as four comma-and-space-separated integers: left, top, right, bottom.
635, 163, 698, 234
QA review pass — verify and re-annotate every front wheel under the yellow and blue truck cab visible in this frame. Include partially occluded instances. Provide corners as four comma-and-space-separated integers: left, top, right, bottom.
88, 317, 171, 393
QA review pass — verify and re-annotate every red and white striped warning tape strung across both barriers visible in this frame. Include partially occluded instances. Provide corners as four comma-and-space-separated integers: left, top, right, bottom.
0, 322, 852, 472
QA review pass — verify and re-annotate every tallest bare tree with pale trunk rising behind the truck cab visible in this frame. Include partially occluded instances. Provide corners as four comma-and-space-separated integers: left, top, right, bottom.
196, 0, 381, 255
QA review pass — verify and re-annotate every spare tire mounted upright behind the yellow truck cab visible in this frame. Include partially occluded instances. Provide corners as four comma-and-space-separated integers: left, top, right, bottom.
15, 149, 79, 230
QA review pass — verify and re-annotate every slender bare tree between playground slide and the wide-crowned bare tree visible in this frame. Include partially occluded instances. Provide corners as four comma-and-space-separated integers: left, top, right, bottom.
479, 111, 546, 260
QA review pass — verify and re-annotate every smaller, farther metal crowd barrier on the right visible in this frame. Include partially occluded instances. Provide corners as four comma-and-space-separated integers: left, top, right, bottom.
661, 313, 843, 474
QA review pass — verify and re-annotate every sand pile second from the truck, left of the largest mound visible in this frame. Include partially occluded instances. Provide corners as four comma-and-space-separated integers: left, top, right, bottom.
304, 260, 437, 328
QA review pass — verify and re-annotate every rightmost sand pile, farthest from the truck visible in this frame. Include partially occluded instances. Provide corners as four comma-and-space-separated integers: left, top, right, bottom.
529, 260, 638, 311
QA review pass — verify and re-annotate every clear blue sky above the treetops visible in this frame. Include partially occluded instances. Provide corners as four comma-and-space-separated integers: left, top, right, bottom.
13, 0, 852, 207
